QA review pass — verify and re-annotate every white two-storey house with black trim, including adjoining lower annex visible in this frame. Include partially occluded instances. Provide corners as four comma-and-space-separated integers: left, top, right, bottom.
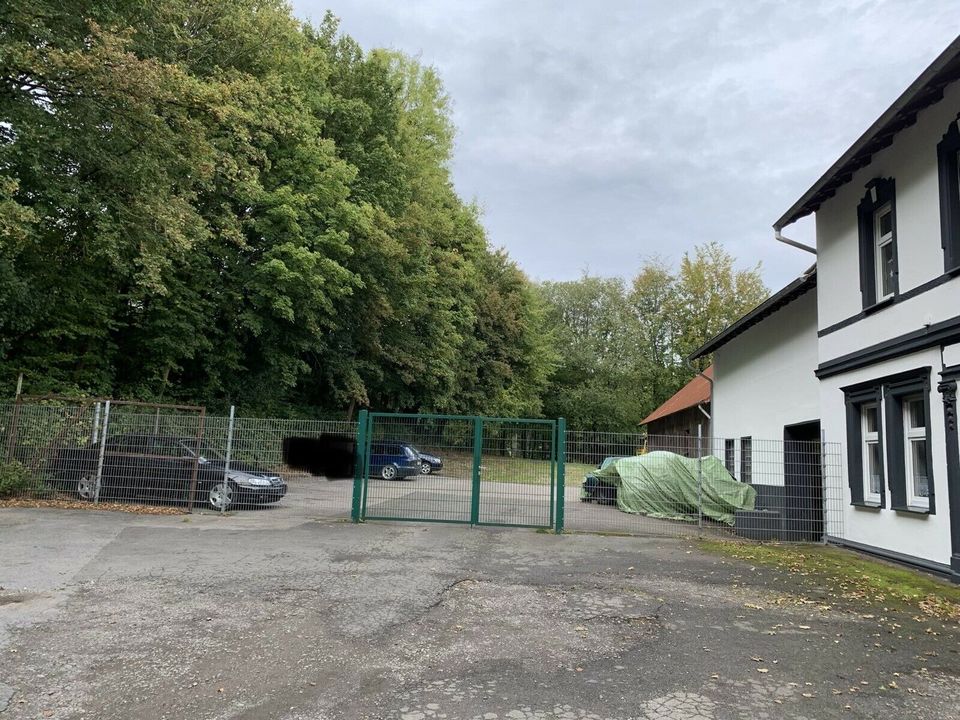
698, 38, 960, 580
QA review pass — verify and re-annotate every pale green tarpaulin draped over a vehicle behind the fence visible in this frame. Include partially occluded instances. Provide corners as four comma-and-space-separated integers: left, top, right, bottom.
596, 451, 757, 525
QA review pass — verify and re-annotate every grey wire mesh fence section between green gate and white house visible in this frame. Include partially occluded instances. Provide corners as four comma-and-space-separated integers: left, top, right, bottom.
566, 431, 843, 542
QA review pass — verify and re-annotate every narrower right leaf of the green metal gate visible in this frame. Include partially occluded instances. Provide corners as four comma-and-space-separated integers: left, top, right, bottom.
476, 419, 557, 528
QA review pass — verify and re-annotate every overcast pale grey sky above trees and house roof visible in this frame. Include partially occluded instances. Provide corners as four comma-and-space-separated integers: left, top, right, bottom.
293, 0, 960, 289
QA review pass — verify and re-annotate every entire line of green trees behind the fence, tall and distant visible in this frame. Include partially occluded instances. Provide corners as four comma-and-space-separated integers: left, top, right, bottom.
0, 0, 765, 430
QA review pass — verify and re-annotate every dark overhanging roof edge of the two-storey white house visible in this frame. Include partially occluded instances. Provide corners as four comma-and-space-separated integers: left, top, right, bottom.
773, 36, 960, 230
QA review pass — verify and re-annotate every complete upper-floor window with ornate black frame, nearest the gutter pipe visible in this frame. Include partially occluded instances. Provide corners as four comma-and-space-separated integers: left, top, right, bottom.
857, 178, 899, 308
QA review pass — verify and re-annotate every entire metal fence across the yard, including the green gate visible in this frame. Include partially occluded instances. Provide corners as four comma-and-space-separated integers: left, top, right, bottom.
0, 399, 844, 541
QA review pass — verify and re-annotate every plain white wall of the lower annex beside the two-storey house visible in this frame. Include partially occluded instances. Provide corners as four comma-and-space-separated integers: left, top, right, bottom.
711, 290, 820, 485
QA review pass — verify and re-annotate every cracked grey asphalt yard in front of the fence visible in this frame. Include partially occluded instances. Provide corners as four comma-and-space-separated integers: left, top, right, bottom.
0, 509, 960, 720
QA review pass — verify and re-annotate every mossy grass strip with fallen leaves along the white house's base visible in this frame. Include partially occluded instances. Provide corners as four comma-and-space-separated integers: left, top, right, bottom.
699, 540, 960, 622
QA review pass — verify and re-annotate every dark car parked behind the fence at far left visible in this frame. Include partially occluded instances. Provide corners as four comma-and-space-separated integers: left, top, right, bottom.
48, 434, 287, 510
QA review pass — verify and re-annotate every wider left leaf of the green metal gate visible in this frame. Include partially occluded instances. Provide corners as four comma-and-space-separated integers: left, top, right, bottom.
362, 413, 479, 523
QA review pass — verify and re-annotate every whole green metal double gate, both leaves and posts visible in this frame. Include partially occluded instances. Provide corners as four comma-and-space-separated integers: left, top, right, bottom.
352, 411, 566, 533
